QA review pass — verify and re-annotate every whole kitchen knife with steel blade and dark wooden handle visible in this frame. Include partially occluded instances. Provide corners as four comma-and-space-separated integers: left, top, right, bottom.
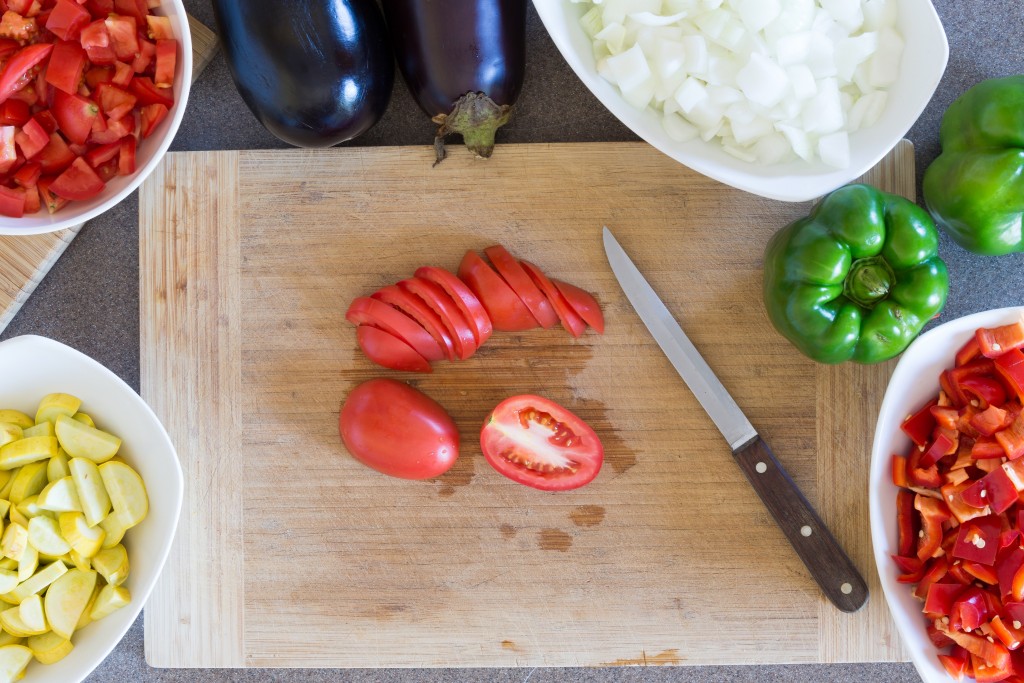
604, 227, 867, 612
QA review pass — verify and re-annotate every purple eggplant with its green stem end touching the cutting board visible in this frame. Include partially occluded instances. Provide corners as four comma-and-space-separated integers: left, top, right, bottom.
383, 0, 526, 165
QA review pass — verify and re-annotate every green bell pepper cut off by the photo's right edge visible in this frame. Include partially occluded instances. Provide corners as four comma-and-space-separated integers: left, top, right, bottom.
924, 76, 1024, 255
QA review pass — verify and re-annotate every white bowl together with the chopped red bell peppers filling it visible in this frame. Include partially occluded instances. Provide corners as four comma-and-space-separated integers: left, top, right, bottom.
869, 307, 1024, 682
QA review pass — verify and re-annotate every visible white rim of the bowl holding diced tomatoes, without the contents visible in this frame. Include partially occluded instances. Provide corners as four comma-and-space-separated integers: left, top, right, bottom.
0, 0, 191, 234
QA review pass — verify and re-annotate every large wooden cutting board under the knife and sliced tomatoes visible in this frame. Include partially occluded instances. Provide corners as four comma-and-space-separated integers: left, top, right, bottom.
139, 142, 914, 667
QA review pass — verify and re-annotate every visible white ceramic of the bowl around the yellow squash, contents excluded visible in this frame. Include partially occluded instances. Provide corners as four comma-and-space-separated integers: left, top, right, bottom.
0, 336, 184, 683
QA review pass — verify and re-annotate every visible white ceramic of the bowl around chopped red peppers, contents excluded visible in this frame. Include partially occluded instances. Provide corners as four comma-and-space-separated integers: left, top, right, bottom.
868, 307, 1024, 683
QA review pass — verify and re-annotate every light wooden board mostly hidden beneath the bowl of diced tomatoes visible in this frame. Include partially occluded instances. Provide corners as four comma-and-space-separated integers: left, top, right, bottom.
0, 15, 217, 332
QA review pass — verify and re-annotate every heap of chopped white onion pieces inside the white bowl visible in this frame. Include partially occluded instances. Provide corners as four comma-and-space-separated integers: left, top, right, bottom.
571, 0, 904, 168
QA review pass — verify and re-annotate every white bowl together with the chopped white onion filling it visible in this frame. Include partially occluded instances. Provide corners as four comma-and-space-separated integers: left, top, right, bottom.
534, 0, 949, 202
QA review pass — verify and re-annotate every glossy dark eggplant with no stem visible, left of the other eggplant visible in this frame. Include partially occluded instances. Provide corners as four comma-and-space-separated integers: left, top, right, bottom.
213, 0, 394, 147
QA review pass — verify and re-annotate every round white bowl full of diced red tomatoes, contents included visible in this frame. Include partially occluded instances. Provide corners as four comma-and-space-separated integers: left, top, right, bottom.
0, 0, 191, 234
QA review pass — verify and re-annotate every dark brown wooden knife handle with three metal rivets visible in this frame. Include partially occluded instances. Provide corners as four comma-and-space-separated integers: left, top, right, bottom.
733, 436, 867, 612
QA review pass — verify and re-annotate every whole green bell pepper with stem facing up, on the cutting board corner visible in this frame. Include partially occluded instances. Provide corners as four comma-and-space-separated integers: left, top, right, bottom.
764, 185, 949, 364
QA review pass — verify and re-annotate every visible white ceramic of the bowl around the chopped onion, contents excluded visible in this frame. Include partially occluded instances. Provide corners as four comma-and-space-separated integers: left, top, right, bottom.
534, 0, 949, 202
